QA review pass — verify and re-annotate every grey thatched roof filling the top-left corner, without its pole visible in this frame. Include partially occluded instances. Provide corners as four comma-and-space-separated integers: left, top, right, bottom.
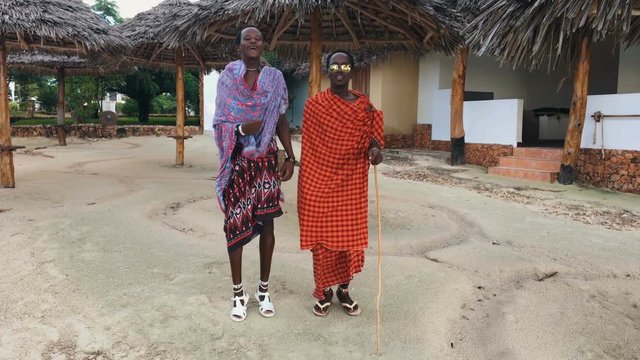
0, 0, 129, 54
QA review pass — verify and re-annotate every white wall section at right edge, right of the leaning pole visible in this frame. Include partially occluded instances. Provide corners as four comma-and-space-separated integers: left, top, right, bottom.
581, 93, 640, 150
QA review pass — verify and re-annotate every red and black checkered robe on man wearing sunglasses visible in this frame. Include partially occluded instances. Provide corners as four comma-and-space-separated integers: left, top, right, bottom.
298, 89, 384, 299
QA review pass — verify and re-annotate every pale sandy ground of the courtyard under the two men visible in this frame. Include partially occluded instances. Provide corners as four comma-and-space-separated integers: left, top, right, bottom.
0, 136, 640, 359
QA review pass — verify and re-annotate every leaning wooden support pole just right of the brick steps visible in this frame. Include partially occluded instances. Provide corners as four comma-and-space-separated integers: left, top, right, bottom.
558, 35, 591, 185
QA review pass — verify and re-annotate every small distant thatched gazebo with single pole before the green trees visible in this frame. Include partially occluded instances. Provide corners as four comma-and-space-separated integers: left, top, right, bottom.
7, 51, 127, 146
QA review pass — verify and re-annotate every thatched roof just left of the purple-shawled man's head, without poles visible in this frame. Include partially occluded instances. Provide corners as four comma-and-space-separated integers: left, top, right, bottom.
118, 0, 230, 69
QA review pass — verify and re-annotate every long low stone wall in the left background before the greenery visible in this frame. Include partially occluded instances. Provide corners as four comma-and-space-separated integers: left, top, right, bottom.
11, 124, 199, 139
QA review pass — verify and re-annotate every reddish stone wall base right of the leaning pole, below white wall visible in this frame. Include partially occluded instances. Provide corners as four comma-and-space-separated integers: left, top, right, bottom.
576, 149, 640, 194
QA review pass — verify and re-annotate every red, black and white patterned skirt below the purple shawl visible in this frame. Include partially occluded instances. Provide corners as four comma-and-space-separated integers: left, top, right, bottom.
222, 140, 282, 252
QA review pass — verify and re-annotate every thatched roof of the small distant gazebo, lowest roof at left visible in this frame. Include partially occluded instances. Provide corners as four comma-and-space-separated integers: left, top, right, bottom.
7, 51, 129, 76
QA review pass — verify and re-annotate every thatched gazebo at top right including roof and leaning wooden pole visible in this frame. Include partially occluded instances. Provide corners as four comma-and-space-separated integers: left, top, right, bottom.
465, 0, 640, 184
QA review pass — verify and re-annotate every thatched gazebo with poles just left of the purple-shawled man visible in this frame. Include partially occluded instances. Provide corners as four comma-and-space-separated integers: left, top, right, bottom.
119, 0, 228, 165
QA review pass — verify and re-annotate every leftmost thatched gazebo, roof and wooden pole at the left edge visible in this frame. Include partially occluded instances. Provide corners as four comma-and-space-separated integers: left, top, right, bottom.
0, 0, 128, 188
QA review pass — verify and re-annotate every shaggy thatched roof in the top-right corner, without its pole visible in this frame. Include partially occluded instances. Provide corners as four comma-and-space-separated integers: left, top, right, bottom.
465, 0, 640, 69
